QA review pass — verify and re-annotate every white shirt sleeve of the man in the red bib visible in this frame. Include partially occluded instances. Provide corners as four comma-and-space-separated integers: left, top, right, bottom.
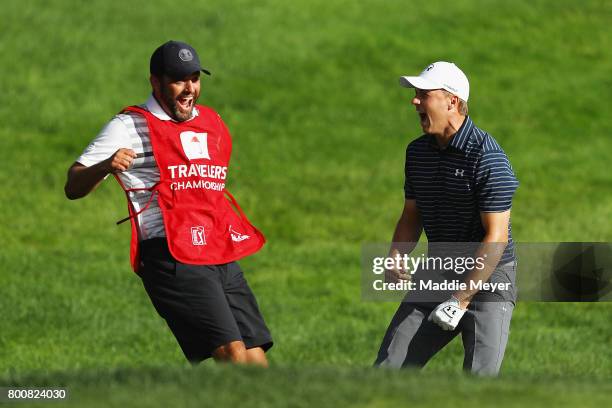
76, 116, 132, 167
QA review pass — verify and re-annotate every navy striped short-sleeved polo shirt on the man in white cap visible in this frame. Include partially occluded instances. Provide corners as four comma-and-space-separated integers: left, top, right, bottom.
404, 116, 518, 264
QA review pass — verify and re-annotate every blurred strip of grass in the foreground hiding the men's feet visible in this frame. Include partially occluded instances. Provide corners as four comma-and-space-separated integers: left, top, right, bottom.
4, 367, 612, 407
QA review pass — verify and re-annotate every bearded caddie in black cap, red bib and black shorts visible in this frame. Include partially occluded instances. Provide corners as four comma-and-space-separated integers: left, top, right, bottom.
65, 41, 272, 366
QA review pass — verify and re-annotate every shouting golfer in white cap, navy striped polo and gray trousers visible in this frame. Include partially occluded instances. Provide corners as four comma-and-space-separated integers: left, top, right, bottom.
375, 61, 518, 375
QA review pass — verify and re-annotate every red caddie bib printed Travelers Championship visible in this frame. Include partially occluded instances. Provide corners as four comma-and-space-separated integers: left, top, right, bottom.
116, 105, 265, 271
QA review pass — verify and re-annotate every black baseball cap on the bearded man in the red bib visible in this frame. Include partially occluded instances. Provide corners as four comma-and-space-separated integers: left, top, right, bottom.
150, 41, 210, 79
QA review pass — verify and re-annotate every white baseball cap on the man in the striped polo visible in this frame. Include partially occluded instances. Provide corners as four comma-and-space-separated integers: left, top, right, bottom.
400, 61, 470, 102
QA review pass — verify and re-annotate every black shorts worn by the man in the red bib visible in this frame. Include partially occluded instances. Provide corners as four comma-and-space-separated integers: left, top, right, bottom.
139, 238, 273, 363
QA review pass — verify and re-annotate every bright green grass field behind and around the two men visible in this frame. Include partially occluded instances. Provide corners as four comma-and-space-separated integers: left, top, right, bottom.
0, 0, 612, 407
